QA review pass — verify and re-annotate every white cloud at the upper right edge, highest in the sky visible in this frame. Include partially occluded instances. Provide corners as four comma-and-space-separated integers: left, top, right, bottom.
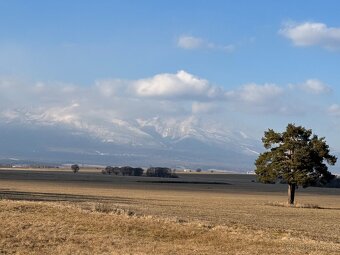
279, 22, 340, 50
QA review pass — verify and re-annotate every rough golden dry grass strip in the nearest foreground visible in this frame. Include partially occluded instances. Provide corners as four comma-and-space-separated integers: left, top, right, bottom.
0, 200, 340, 254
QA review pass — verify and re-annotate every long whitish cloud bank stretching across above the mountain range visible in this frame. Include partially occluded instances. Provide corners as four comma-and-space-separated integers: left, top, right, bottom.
0, 71, 334, 144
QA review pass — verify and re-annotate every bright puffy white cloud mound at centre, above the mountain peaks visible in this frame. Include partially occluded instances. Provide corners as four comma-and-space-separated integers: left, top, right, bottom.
132, 71, 223, 100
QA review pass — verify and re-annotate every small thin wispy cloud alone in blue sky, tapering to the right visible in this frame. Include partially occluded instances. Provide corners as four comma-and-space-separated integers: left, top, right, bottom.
177, 35, 235, 52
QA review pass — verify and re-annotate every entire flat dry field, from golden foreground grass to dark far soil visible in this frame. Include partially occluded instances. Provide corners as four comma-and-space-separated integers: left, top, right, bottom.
0, 169, 340, 254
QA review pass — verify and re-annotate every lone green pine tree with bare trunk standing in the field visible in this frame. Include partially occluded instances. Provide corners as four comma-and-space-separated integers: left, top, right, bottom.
255, 124, 337, 205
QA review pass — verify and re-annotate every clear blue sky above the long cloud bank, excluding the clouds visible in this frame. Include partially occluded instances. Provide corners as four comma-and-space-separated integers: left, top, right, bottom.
0, 1, 340, 84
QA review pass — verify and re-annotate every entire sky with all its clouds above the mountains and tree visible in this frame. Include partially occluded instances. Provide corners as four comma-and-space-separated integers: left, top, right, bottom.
0, 0, 340, 151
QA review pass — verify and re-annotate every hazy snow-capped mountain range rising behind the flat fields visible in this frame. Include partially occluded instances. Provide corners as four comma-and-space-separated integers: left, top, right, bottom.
0, 110, 261, 170
